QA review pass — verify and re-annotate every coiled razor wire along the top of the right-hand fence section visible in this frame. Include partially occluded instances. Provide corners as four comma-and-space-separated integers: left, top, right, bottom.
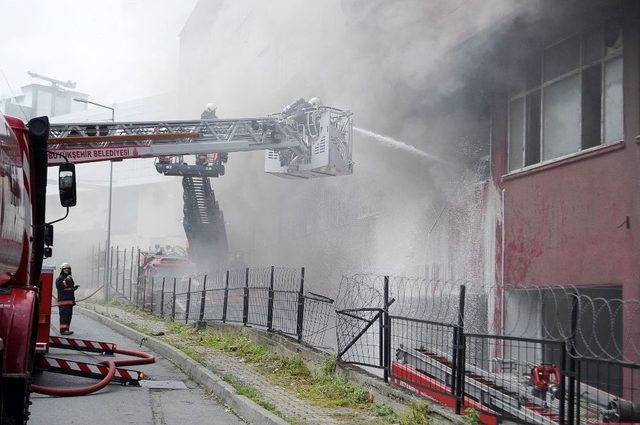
335, 267, 640, 364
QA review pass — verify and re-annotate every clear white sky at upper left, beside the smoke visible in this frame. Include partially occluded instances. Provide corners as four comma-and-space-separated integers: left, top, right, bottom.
0, 0, 197, 104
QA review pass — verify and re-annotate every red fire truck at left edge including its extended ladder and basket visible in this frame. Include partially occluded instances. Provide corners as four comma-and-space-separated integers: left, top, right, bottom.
0, 102, 353, 424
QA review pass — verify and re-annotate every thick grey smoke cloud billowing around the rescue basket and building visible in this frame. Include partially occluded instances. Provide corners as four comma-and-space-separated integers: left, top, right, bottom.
42, 0, 536, 295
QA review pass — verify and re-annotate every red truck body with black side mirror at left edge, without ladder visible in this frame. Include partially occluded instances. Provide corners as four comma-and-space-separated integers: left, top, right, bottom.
0, 114, 75, 424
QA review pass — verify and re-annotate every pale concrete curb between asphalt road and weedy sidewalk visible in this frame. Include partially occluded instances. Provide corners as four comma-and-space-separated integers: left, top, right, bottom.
76, 306, 287, 425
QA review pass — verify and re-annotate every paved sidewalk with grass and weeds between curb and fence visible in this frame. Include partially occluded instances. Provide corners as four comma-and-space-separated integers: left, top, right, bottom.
85, 304, 436, 425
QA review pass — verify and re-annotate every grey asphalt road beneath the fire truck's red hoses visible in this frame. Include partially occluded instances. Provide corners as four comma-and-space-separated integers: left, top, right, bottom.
29, 310, 243, 425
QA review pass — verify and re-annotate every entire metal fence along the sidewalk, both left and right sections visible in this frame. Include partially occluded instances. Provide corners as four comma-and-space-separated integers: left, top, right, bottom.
94, 247, 640, 425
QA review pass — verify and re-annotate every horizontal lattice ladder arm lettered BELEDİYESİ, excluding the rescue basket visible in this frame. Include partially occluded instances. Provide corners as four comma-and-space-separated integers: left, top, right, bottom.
49, 118, 307, 165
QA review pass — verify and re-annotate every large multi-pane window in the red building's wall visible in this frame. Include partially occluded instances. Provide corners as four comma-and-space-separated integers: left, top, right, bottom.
508, 25, 623, 171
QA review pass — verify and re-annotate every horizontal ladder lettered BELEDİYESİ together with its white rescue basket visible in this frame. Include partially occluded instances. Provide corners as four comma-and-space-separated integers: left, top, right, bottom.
48, 107, 353, 178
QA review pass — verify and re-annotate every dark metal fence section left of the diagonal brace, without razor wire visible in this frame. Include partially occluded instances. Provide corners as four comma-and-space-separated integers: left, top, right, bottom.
94, 247, 335, 350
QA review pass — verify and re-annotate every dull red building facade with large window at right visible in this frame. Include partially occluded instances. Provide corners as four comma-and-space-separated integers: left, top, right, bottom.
482, 1, 640, 362
